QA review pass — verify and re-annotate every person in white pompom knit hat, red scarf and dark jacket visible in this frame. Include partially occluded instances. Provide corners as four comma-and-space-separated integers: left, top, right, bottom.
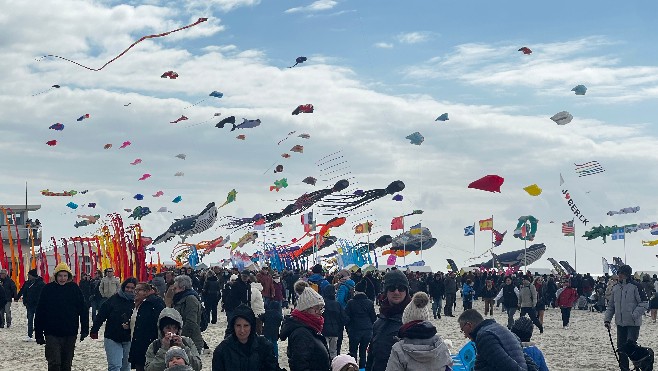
280, 281, 331, 371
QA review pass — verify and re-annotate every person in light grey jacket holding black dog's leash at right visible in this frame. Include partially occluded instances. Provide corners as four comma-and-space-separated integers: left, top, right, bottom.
603, 265, 649, 370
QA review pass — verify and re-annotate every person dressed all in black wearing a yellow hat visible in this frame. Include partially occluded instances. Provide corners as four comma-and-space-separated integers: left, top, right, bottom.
34, 262, 89, 371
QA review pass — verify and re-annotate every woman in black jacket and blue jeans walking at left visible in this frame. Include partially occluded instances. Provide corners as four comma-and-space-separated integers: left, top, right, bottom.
89, 277, 137, 371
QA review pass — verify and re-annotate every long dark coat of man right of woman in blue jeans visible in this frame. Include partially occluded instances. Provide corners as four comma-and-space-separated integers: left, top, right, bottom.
128, 294, 165, 366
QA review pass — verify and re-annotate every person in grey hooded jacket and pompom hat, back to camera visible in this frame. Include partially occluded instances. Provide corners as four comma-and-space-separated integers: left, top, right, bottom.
386, 291, 452, 371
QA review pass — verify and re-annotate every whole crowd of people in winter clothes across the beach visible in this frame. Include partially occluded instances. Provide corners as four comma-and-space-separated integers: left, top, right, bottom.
0, 263, 658, 371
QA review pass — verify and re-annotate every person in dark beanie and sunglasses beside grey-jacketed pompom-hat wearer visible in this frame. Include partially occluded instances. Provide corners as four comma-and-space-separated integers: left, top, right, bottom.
366, 269, 411, 371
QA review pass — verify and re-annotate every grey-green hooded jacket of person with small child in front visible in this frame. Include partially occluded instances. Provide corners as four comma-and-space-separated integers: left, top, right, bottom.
145, 308, 202, 371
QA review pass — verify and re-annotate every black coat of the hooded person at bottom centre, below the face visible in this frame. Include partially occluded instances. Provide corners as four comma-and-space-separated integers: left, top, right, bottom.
212, 330, 279, 371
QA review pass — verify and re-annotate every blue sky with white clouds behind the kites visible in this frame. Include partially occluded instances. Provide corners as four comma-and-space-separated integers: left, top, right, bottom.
0, 0, 658, 273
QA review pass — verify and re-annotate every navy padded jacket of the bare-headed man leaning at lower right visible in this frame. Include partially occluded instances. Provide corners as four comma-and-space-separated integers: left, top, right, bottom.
471, 319, 528, 371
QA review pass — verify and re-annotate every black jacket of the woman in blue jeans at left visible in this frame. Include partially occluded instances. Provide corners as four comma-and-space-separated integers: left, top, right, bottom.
89, 293, 135, 343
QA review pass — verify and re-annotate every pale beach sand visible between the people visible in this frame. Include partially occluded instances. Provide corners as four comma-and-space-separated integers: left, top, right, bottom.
0, 301, 658, 371
